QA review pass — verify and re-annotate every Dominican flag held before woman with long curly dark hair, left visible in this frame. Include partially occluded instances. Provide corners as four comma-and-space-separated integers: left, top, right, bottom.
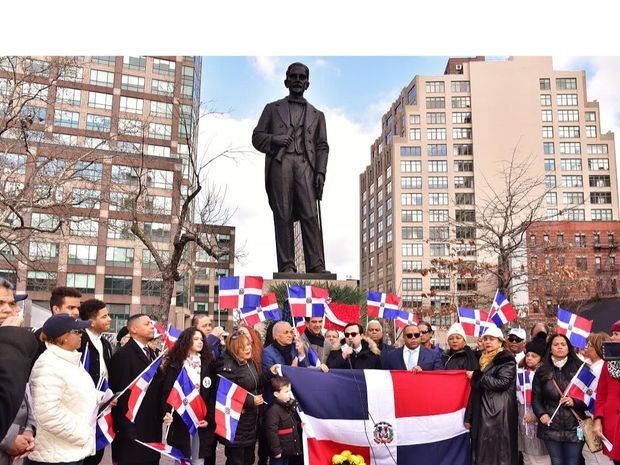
166, 367, 207, 436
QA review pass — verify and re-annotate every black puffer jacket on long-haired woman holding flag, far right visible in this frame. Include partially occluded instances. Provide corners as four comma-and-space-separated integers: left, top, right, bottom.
532, 358, 586, 442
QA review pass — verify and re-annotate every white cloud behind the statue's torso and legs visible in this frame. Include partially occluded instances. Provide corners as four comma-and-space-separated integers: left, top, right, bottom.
200, 108, 379, 278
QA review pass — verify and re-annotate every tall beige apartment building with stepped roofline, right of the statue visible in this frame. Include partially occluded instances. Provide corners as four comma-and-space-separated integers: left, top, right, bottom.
360, 57, 618, 324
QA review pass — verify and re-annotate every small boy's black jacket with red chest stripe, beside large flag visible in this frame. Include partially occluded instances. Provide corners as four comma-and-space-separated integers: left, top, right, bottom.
263, 397, 303, 457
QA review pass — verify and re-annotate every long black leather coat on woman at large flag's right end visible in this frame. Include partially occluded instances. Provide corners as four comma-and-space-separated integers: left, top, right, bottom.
465, 350, 519, 465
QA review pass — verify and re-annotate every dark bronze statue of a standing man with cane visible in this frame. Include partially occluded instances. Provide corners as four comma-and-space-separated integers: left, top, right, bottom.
252, 63, 329, 273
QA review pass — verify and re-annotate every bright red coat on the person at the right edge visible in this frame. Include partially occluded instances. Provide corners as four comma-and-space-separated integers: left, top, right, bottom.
594, 362, 620, 460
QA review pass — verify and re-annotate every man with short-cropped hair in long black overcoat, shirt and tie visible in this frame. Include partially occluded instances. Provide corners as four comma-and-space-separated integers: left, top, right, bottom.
110, 314, 163, 465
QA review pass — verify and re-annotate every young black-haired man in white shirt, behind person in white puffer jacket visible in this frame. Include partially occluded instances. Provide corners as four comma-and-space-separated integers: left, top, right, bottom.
79, 299, 112, 465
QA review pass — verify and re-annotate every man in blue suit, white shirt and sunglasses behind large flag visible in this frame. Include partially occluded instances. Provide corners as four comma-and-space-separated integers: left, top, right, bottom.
383, 325, 443, 373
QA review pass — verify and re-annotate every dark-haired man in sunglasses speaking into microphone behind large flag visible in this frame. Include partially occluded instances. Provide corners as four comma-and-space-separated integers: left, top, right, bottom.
327, 323, 381, 370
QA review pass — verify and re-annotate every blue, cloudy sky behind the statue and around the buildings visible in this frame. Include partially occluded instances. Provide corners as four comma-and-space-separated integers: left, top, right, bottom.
199, 57, 620, 279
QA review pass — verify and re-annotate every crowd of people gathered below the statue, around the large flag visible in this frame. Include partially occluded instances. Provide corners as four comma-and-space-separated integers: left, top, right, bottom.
0, 280, 620, 465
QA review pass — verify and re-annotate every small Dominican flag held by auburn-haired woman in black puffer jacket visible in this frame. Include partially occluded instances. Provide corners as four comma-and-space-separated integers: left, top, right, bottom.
215, 376, 249, 442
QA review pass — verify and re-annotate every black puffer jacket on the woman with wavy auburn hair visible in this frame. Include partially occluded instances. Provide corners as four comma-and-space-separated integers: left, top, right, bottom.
217, 351, 265, 447
